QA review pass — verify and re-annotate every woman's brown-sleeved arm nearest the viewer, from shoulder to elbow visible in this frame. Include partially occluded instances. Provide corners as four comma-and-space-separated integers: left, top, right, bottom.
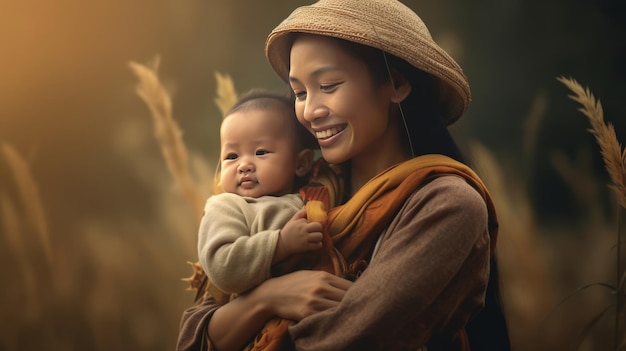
290, 176, 490, 350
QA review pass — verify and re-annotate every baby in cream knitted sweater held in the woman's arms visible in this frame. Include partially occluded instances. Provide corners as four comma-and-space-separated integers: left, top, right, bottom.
198, 91, 323, 294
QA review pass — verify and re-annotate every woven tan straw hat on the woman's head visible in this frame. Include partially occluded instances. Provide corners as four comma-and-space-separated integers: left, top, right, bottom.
265, 0, 471, 125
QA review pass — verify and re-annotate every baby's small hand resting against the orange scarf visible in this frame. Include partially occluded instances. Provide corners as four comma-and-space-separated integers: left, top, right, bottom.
276, 209, 323, 258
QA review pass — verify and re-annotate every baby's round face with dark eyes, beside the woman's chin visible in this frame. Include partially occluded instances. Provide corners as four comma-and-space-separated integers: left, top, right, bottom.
220, 108, 297, 197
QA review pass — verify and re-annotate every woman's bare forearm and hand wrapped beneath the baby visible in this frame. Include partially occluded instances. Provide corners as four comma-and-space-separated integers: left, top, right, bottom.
209, 271, 352, 350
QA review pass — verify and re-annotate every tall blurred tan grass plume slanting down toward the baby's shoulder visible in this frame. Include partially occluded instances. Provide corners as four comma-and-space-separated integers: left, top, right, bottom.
129, 60, 204, 223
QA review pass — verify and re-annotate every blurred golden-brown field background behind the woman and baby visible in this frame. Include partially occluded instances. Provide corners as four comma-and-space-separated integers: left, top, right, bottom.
0, 0, 626, 351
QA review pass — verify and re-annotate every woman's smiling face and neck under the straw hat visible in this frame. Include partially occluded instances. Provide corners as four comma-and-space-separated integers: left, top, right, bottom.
289, 34, 401, 165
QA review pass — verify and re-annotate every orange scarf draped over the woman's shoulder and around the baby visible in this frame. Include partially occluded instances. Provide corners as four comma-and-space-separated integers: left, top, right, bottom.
246, 155, 498, 351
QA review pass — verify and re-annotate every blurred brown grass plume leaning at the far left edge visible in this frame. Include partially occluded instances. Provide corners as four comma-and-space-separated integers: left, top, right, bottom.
2, 144, 52, 263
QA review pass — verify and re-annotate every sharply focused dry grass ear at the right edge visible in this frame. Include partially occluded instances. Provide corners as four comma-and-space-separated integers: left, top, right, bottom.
557, 77, 626, 208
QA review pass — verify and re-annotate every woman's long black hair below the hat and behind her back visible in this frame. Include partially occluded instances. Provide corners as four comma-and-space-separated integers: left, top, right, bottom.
337, 39, 511, 351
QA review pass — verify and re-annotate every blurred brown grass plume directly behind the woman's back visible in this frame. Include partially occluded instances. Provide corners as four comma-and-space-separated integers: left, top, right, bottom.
470, 142, 556, 350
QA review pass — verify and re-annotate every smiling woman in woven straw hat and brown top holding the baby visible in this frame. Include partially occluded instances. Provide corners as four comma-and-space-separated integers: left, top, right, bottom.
179, 0, 510, 350
